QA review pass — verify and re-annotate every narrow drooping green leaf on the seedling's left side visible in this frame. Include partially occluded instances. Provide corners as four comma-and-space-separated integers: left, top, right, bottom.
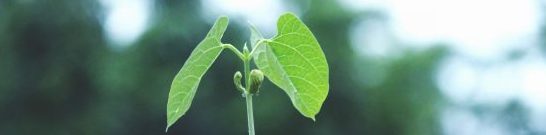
165, 17, 228, 131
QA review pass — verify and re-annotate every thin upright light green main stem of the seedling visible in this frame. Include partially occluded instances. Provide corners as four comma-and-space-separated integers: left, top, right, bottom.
243, 51, 255, 135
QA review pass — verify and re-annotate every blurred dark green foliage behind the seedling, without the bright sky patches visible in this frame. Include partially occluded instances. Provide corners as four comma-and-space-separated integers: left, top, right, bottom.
0, 0, 536, 135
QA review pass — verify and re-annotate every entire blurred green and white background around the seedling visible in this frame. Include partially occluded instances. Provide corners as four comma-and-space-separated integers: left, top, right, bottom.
0, 0, 546, 135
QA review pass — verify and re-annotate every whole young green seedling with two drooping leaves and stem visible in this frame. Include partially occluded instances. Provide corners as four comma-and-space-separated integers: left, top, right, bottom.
166, 13, 329, 135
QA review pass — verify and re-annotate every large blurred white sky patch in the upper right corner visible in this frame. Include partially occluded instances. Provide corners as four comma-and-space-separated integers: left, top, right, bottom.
340, 0, 541, 60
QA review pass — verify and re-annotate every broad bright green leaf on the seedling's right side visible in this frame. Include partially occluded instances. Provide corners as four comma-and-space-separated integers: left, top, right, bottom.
251, 13, 329, 120
